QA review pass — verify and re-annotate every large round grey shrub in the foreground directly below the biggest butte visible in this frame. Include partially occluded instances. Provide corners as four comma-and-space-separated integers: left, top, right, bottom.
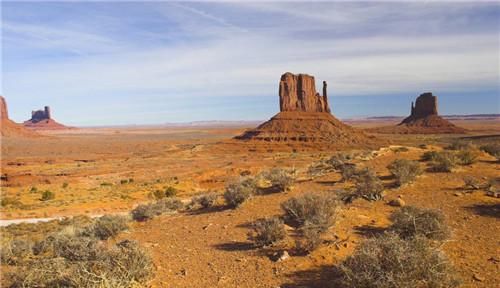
281, 193, 339, 231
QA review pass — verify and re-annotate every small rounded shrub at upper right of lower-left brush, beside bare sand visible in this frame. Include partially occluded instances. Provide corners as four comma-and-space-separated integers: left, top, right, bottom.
84, 215, 128, 240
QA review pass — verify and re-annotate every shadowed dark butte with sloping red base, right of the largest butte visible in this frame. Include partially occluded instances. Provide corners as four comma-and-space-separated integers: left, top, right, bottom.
370, 92, 466, 134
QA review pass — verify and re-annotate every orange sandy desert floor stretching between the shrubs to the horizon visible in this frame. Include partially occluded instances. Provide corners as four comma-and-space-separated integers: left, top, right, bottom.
1, 120, 500, 287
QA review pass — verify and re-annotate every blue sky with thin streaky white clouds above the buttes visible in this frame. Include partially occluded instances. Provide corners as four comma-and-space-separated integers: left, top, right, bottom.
0, 1, 500, 126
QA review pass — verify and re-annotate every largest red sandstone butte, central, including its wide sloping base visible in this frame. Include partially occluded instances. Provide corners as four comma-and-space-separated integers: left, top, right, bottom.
235, 72, 378, 149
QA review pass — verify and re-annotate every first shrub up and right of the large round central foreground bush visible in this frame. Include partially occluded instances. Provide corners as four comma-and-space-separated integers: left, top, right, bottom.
354, 168, 384, 201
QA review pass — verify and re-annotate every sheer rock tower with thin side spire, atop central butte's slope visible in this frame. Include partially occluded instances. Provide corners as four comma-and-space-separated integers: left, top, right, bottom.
279, 72, 330, 113
